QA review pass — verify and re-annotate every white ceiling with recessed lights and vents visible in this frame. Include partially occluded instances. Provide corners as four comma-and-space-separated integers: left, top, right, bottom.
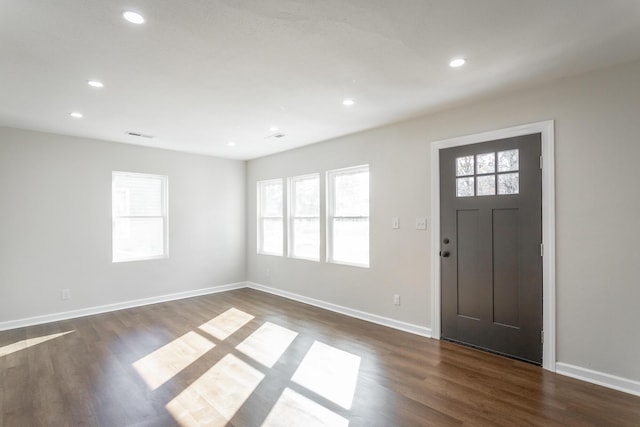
0, 0, 640, 159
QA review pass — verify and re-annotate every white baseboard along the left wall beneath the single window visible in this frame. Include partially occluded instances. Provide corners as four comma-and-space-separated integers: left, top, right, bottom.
0, 282, 247, 331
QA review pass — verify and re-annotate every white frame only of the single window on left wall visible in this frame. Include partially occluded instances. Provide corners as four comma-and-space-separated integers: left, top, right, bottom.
111, 171, 169, 263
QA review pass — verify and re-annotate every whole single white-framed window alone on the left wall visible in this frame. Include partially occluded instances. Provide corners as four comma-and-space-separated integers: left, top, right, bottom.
111, 172, 168, 262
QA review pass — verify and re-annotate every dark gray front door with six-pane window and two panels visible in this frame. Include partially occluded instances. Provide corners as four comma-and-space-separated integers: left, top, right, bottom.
440, 134, 542, 364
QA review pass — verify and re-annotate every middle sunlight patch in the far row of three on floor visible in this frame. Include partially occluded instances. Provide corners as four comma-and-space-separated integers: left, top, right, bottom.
236, 322, 298, 368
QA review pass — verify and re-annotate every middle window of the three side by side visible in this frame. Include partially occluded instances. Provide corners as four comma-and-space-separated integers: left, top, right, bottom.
289, 174, 320, 261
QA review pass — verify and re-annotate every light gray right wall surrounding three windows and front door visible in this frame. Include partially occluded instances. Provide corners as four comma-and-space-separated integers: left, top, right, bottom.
247, 58, 640, 382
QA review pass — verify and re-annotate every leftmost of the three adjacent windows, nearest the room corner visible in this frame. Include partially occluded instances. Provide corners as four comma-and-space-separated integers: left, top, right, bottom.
258, 179, 284, 255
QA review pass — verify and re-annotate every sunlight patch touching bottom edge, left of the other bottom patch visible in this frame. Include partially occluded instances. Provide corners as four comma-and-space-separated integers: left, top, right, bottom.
166, 354, 264, 427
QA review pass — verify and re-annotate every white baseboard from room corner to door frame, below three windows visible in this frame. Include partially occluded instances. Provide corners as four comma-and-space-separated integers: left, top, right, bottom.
247, 282, 431, 338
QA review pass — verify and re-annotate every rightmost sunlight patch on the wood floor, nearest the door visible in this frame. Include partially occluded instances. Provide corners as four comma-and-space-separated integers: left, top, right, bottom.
291, 341, 360, 409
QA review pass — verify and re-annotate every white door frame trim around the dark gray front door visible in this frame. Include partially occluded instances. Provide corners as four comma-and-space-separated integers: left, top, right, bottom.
431, 120, 556, 372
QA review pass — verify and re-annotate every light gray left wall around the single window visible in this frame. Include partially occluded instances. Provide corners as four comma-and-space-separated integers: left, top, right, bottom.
0, 128, 246, 323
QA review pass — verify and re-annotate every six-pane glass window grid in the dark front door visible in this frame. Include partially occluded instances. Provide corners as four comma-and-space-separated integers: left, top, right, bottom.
456, 149, 520, 197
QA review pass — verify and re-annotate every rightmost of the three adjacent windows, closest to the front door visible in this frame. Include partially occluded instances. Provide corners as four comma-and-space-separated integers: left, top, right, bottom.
327, 165, 369, 267
